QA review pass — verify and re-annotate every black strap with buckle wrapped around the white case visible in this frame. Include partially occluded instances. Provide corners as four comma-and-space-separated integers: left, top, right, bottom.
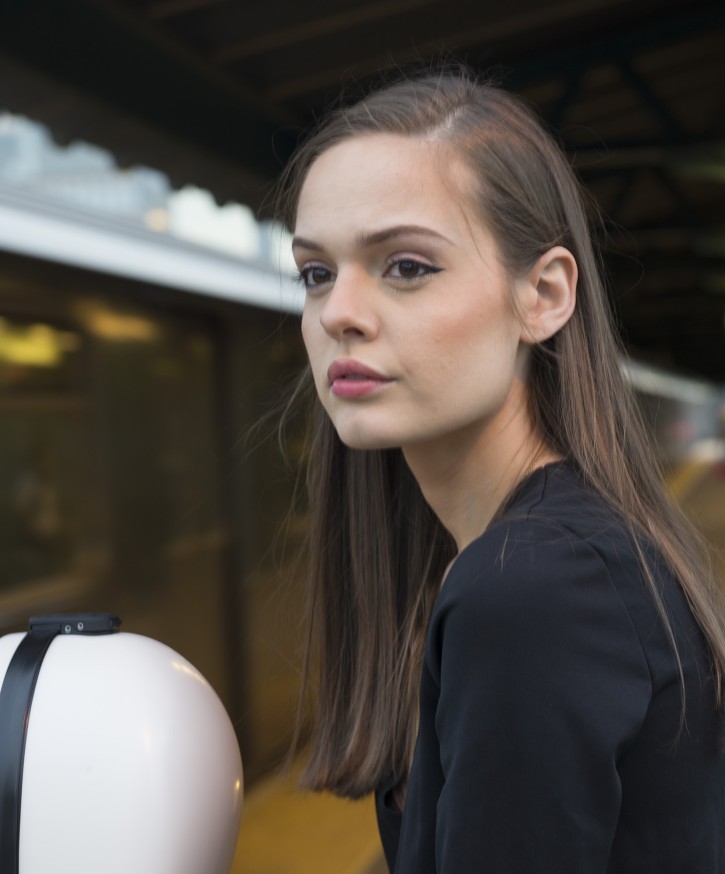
0, 613, 121, 874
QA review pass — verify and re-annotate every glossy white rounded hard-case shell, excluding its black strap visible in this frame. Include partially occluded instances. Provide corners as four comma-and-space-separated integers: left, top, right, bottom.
0, 612, 243, 874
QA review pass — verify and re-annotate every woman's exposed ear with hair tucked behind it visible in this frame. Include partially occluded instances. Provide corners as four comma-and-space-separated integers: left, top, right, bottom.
519, 246, 579, 343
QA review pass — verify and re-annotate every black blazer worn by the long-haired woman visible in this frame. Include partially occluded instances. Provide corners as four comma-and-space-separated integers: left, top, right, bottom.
376, 463, 725, 874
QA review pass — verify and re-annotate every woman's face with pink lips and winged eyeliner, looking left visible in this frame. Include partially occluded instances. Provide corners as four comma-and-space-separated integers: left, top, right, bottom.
293, 134, 527, 449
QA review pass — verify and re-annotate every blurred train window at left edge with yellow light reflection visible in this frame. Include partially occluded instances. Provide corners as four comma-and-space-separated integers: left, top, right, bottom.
0, 316, 86, 594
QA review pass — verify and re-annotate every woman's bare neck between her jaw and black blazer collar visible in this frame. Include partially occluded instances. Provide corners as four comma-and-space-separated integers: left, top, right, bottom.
403, 398, 556, 552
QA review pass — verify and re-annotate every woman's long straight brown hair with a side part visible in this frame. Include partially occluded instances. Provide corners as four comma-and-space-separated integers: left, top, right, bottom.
280, 71, 725, 797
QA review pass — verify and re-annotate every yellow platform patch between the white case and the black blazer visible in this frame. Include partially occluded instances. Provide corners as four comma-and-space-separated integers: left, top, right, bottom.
231, 774, 388, 874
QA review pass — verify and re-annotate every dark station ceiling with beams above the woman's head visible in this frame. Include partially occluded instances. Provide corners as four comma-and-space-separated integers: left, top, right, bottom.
0, 0, 725, 383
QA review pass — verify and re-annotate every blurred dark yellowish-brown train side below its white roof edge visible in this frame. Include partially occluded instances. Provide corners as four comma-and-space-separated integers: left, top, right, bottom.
0, 220, 304, 785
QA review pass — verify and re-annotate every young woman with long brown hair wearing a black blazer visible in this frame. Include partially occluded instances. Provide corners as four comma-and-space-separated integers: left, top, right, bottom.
284, 74, 725, 874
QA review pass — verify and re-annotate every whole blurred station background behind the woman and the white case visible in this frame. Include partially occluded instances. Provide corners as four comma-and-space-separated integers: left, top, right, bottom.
0, 0, 725, 874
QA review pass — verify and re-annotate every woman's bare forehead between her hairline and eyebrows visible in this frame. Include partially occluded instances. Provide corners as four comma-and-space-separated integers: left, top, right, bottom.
295, 134, 477, 236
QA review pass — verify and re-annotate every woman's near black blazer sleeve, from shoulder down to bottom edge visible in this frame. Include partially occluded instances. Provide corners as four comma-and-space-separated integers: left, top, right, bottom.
425, 537, 652, 874
